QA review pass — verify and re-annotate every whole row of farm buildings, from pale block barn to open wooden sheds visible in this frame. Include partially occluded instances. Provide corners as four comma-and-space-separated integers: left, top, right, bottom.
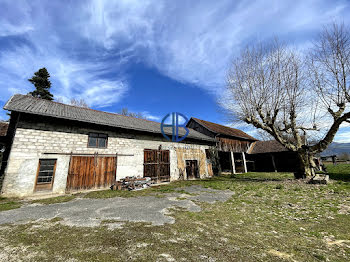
0, 95, 297, 196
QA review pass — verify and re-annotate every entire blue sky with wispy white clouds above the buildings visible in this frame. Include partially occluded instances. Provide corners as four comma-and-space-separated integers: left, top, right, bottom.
0, 0, 350, 142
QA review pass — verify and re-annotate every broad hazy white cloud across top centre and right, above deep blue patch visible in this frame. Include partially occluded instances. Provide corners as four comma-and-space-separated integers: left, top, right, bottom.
73, 0, 346, 92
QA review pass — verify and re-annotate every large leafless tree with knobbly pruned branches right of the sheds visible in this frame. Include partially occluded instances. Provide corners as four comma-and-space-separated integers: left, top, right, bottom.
223, 25, 350, 178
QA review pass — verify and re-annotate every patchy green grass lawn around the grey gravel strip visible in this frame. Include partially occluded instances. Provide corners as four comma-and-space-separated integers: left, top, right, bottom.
0, 171, 350, 261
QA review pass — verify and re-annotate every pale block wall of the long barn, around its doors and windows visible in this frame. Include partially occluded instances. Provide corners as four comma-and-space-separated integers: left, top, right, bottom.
2, 117, 209, 196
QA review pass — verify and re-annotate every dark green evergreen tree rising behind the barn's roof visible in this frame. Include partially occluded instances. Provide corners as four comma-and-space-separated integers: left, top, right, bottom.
28, 67, 53, 101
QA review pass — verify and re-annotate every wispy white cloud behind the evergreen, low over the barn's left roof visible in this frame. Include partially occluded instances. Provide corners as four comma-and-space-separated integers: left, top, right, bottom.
0, 44, 129, 107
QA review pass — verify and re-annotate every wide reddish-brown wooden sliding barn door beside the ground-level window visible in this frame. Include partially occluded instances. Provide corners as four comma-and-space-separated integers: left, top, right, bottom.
66, 156, 116, 191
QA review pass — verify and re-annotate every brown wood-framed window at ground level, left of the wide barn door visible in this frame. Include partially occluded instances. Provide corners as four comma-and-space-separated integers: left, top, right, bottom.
35, 159, 57, 190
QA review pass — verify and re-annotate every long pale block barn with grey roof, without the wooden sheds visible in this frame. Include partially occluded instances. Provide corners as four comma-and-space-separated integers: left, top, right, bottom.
0, 95, 219, 196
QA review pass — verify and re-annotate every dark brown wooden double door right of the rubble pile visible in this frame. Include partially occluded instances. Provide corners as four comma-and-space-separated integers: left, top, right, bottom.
143, 149, 170, 183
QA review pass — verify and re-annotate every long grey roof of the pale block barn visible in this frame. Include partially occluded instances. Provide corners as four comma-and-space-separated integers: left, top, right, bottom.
4, 95, 214, 142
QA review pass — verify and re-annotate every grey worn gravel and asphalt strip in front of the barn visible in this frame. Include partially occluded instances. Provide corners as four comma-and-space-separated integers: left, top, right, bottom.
0, 186, 233, 227
